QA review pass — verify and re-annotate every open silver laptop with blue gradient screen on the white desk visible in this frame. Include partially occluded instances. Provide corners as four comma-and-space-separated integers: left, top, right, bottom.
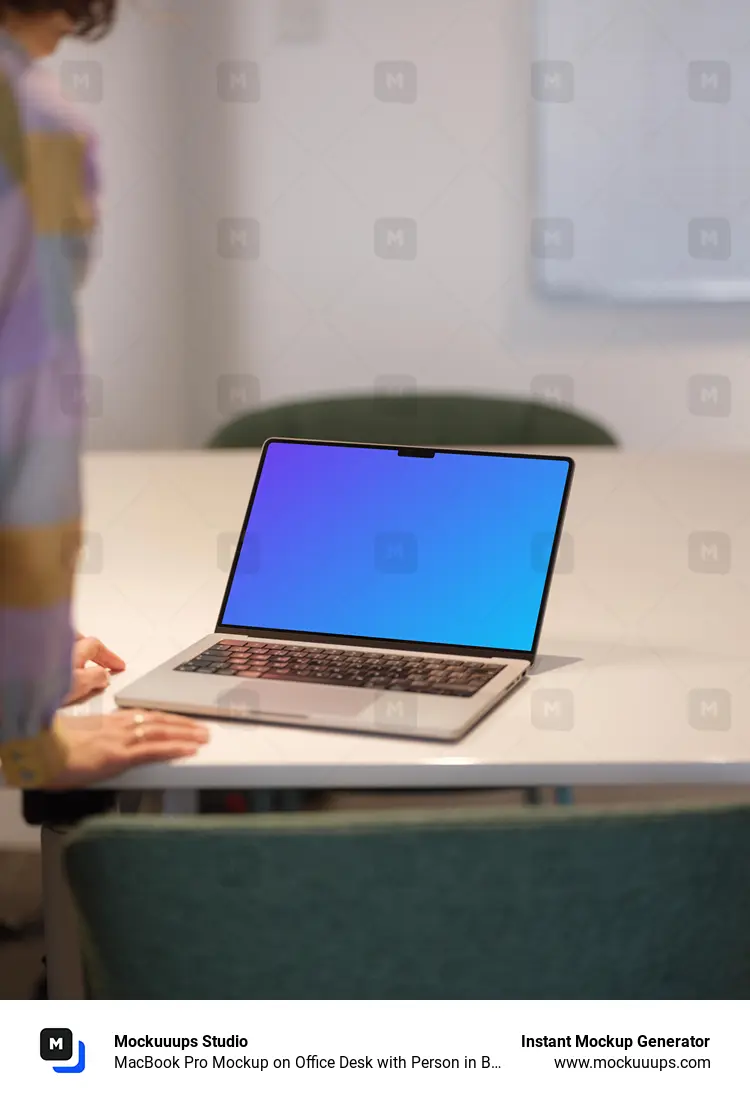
115, 439, 574, 741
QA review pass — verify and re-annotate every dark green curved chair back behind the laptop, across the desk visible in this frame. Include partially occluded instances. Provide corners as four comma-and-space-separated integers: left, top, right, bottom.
210, 393, 617, 448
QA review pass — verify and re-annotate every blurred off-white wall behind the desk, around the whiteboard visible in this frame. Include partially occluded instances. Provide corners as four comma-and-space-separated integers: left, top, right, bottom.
52, 0, 750, 448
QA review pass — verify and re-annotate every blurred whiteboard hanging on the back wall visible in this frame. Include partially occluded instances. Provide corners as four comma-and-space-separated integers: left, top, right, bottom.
531, 0, 750, 303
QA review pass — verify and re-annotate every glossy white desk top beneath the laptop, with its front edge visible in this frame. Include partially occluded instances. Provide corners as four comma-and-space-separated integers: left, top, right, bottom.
67, 451, 750, 789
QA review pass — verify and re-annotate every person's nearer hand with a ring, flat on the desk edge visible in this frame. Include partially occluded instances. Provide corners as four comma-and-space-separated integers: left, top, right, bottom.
46, 711, 209, 791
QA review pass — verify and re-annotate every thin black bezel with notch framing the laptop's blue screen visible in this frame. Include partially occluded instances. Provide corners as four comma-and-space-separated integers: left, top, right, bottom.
214, 436, 575, 662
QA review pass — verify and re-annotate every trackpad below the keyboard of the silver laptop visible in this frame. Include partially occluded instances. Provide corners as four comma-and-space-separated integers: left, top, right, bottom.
217, 684, 371, 722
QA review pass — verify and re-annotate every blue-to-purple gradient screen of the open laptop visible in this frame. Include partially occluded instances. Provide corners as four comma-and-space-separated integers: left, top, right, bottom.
222, 442, 570, 651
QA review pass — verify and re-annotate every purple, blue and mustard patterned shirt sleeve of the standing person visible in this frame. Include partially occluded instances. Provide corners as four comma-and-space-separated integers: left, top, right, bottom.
0, 32, 99, 787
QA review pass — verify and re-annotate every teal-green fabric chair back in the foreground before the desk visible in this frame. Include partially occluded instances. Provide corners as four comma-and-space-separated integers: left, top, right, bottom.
65, 806, 750, 1000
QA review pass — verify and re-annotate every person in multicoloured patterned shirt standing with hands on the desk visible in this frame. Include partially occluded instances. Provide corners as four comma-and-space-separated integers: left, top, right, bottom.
0, 0, 208, 791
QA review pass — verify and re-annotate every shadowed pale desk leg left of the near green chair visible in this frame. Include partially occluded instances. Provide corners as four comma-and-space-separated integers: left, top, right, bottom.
42, 825, 86, 1001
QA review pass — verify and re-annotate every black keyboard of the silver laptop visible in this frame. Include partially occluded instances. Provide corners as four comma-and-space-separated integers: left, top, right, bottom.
176, 638, 504, 697
